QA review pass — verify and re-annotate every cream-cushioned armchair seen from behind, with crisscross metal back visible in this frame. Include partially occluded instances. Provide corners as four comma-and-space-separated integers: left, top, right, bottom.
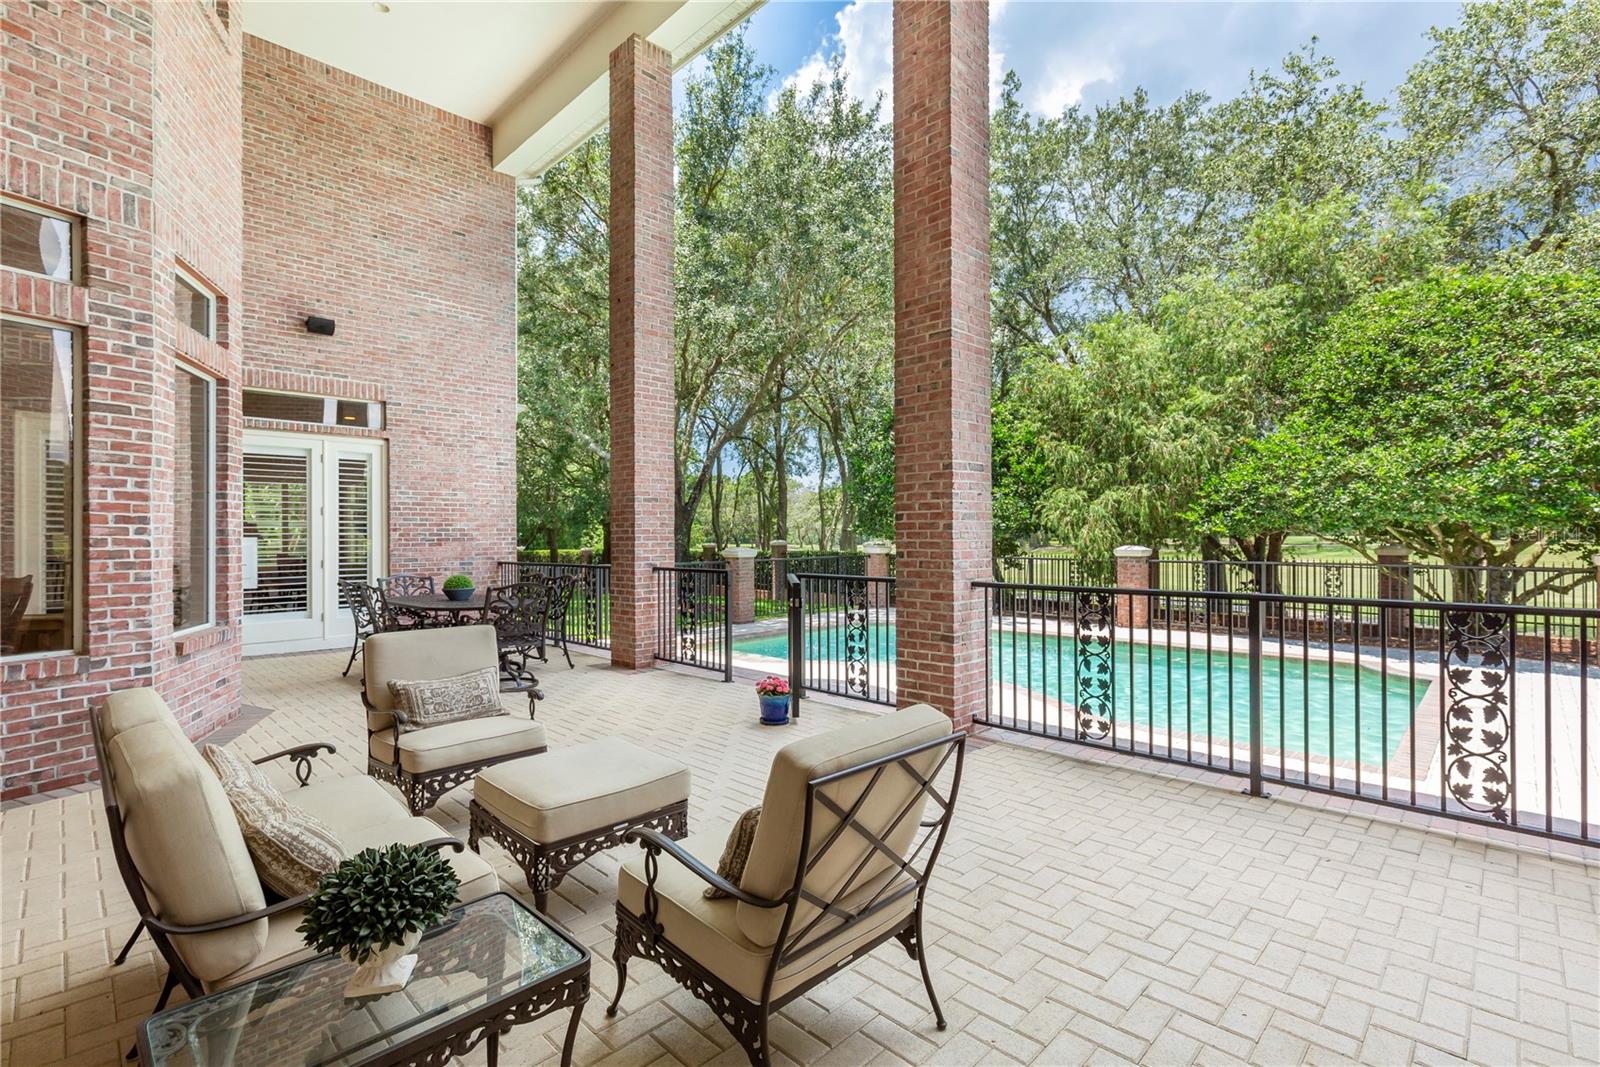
606, 704, 966, 1067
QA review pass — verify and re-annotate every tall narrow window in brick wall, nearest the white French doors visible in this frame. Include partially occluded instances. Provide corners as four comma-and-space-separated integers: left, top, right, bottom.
173, 365, 216, 630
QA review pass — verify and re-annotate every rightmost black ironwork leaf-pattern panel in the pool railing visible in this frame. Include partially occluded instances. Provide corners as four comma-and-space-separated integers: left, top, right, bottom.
1443, 611, 1515, 822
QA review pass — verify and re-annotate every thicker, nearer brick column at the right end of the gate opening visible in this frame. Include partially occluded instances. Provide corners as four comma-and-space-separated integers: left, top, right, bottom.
894, 0, 992, 729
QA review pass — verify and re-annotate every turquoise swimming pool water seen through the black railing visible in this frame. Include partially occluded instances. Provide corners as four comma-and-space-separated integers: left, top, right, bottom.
733, 627, 1427, 765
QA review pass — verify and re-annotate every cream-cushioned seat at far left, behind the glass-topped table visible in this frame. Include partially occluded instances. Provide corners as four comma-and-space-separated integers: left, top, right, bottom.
90, 689, 499, 1011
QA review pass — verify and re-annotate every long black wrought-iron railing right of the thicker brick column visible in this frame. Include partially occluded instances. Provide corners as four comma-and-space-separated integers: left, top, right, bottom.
974, 582, 1600, 841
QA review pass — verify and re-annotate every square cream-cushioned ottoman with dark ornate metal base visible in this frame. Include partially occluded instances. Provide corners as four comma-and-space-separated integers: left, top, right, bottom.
467, 737, 690, 912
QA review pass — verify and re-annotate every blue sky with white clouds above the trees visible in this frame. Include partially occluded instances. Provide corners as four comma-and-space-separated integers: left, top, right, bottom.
675, 0, 1459, 114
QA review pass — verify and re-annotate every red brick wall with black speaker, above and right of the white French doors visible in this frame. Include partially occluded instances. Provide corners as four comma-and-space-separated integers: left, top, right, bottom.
240, 35, 517, 584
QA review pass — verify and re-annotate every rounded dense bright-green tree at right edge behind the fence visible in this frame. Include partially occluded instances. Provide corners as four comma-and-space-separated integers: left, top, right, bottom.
1195, 272, 1600, 595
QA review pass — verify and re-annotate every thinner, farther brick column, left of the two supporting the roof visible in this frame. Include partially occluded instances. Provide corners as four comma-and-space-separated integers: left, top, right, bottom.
610, 34, 677, 667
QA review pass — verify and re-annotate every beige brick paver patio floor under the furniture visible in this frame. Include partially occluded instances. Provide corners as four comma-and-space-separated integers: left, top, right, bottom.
0, 653, 1600, 1067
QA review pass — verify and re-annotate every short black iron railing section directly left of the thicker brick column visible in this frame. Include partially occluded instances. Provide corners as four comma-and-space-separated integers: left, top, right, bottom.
787, 573, 894, 705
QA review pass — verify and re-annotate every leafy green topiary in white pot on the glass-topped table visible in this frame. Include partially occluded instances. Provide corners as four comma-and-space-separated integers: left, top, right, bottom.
296, 845, 461, 997
